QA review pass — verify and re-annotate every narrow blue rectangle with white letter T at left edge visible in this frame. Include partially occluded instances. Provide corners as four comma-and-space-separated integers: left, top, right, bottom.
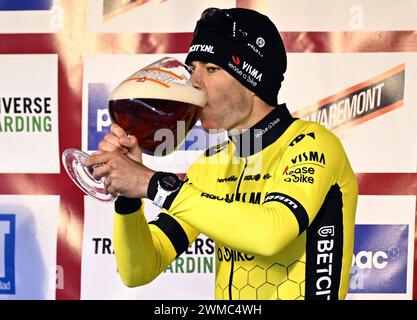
0, 214, 16, 294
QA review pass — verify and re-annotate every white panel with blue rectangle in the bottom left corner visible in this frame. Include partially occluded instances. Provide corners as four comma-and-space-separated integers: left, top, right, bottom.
0, 195, 62, 300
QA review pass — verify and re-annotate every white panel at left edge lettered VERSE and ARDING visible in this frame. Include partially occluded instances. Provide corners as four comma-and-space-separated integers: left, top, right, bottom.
0, 54, 59, 173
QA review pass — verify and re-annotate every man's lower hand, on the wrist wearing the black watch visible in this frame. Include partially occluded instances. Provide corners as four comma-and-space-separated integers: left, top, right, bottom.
84, 151, 155, 198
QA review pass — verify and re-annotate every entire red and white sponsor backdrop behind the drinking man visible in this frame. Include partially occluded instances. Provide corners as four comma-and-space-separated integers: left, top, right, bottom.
0, 0, 417, 299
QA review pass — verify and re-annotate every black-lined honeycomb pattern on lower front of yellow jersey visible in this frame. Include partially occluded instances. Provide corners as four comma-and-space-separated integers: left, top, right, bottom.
216, 260, 305, 300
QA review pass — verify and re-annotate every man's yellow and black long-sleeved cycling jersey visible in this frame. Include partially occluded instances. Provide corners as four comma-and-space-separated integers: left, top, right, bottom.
114, 105, 358, 300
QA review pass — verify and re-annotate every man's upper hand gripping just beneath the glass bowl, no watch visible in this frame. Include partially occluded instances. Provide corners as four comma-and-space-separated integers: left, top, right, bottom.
98, 124, 142, 163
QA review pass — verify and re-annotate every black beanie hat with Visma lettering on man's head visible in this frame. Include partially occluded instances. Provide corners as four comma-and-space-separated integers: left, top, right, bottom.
185, 8, 287, 106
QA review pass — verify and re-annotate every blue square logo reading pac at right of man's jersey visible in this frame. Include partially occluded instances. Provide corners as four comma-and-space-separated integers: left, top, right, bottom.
349, 225, 408, 293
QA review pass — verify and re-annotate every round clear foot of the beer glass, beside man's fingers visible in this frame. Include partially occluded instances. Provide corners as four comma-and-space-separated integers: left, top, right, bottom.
62, 149, 116, 201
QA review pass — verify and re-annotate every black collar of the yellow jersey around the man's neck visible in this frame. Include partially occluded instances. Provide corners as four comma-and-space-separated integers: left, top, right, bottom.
228, 103, 296, 158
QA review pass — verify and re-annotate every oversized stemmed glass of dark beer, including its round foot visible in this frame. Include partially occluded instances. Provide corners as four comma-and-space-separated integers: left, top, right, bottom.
62, 57, 207, 201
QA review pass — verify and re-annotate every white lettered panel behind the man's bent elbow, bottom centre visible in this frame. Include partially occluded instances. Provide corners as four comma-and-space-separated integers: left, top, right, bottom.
81, 197, 215, 300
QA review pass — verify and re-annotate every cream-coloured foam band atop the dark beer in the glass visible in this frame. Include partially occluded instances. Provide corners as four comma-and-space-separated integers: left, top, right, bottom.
109, 79, 207, 107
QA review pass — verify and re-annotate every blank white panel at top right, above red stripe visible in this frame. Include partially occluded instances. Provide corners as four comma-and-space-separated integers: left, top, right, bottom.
264, 0, 417, 31
